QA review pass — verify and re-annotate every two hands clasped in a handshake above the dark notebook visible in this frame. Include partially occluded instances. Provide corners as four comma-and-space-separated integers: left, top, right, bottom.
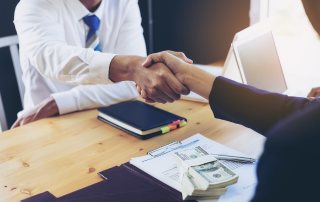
110, 51, 215, 104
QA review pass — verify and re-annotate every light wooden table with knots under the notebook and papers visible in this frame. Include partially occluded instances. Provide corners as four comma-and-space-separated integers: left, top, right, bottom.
0, 62, 265, 202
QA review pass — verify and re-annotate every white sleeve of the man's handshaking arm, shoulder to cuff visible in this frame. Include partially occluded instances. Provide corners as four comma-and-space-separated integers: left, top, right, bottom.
14, 0, 114, 85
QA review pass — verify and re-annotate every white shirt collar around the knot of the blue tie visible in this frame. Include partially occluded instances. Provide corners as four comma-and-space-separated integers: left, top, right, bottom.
67, 0, 105, 21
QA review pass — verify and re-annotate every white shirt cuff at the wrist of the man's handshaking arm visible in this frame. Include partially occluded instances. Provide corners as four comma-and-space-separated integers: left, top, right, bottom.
89, 53, 116, 84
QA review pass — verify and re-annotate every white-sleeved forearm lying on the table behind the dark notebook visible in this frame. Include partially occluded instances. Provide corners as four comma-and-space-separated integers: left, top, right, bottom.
52, 81, 139, 115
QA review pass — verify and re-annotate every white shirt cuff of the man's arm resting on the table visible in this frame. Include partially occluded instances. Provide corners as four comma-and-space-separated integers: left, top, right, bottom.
51, 90, 78, 115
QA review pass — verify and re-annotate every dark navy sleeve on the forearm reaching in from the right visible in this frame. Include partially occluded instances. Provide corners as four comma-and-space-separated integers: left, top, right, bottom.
209, 77, 310, 135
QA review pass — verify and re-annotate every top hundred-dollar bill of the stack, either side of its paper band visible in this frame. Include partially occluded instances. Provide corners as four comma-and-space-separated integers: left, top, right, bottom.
174, 146, 238, 189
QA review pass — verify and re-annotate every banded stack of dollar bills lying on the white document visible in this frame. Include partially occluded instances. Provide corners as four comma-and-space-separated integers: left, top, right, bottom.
173, 146, 239, 200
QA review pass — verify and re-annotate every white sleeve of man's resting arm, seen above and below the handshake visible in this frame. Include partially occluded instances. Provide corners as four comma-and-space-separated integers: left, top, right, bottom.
52, 0, 147, 115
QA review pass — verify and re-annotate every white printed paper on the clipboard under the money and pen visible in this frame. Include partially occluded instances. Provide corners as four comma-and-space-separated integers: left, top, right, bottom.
130, 134, 257, 202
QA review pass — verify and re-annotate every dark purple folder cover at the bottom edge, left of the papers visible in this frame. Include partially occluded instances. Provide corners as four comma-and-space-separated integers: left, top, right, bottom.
23, 165, 188, 202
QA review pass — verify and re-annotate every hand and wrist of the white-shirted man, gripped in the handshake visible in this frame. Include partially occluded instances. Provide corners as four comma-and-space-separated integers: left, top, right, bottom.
109, 56, 192, 104
